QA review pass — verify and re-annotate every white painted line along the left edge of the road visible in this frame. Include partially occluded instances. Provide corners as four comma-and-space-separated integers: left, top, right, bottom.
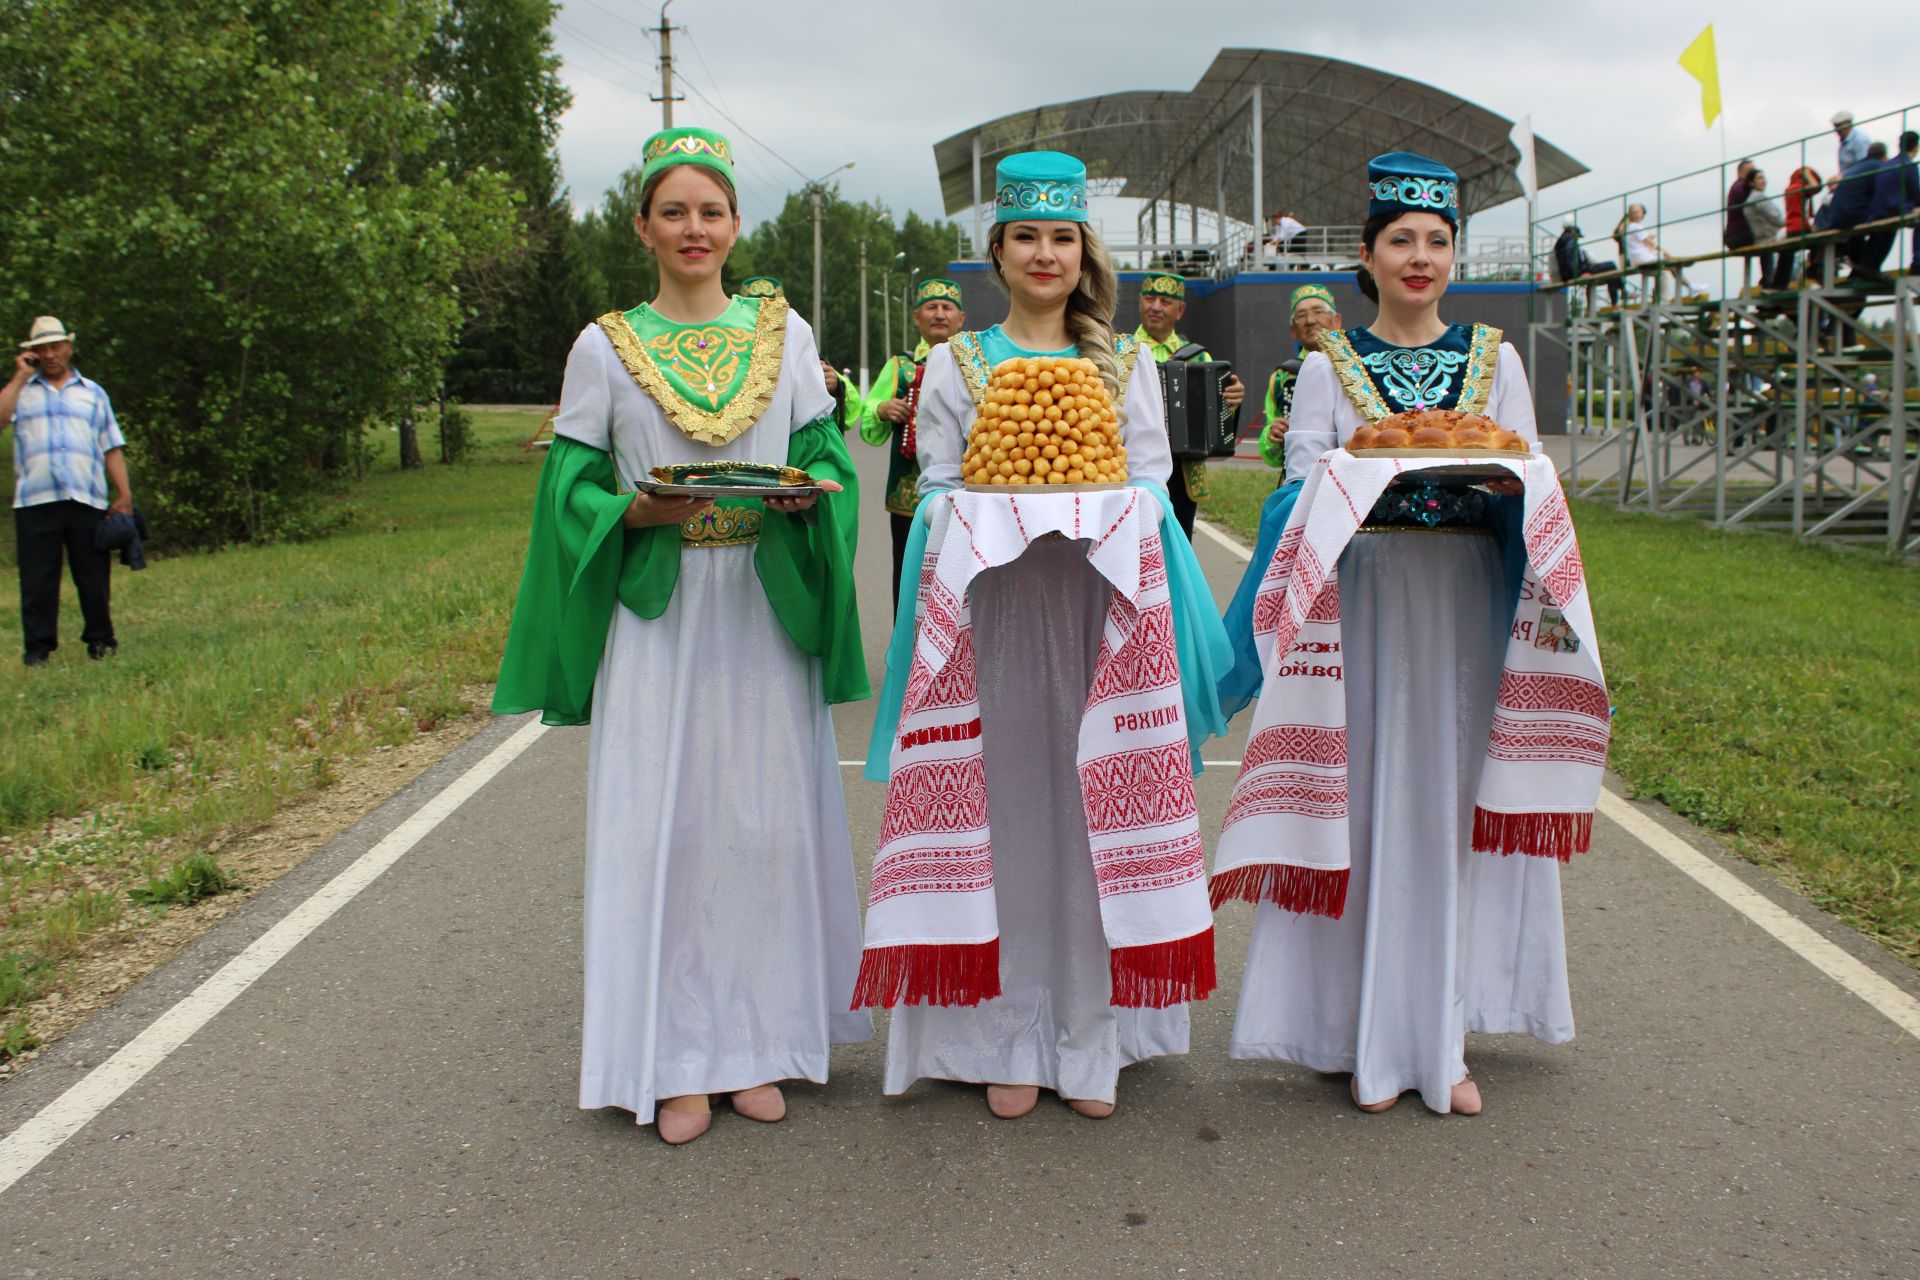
0, 722, 547, 1192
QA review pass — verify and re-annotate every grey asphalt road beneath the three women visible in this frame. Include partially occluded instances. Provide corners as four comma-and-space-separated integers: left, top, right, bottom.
0, 449, 1920, 1280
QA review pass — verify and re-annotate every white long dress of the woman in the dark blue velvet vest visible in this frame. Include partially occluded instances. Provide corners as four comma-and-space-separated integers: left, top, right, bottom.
1231, 344, 1572, 1111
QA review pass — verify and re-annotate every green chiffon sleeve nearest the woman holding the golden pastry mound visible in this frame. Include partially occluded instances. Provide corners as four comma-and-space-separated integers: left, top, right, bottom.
753, 418, 874, 702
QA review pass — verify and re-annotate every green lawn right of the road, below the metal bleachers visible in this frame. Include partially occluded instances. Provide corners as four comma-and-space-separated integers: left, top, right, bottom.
1202, 468, 1920, 965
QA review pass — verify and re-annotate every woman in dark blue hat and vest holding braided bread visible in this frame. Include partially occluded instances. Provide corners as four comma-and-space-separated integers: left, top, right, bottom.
1231, 152, 1572, 1115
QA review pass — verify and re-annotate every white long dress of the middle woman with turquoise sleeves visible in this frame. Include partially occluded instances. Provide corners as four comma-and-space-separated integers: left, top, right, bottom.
885, 335, 1187, 1102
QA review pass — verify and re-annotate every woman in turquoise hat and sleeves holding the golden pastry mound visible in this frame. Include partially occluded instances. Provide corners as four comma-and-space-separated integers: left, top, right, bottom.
868, 152, 1227, 1119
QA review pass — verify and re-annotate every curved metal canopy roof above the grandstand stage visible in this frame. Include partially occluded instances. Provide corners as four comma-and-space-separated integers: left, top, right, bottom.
933, 48, 1586, 226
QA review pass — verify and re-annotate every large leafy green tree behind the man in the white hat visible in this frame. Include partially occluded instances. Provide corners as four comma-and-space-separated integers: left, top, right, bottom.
0, 0, 515, 541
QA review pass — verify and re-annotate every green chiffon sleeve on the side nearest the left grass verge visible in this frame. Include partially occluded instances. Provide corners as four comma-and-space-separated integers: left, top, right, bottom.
493, 436, 680, 725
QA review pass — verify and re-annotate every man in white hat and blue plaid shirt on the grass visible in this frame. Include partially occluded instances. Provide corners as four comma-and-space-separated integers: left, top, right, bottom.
0, 315, 132, 666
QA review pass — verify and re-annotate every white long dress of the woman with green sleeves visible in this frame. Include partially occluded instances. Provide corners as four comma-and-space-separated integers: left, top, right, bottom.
553, 303, 874, 1125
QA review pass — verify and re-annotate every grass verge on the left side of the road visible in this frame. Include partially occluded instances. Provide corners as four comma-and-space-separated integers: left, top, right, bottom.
0, 413, 543, 1043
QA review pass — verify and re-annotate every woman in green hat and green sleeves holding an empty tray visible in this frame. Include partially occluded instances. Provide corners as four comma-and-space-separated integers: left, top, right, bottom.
493, 129, 872, 1144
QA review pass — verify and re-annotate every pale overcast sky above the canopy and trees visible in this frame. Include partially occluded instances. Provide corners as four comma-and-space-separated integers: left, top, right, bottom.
555, 0, 1920, 257
